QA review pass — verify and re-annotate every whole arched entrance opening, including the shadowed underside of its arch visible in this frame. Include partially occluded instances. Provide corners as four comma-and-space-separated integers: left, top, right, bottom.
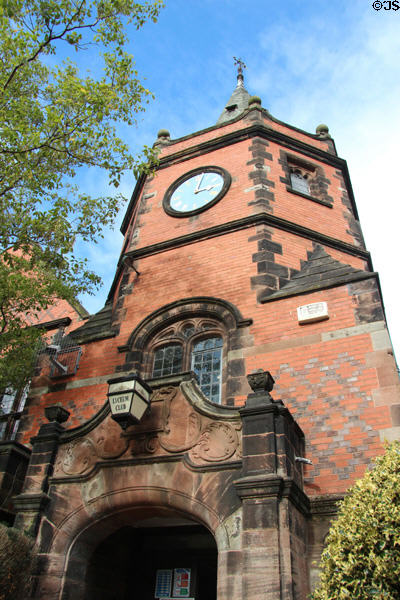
61, 507, 218, 600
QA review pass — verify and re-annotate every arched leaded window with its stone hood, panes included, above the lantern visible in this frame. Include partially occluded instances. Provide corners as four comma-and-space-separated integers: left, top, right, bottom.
125, 296, 252, 406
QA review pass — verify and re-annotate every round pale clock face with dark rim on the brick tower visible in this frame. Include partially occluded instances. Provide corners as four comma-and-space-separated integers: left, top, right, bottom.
164, 167, 231, 217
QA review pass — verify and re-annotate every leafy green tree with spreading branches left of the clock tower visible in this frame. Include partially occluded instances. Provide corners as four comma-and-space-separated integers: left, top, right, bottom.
0, 0, 162, 389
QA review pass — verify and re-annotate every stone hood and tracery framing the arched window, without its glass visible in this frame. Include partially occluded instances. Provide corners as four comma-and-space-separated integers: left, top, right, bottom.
118, 296, 252, 406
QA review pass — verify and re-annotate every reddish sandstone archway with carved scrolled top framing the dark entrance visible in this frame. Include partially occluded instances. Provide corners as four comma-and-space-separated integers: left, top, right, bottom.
29, 380, 242, 600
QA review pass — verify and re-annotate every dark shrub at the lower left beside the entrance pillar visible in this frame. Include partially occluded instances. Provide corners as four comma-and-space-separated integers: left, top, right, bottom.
0, 523, 35, 600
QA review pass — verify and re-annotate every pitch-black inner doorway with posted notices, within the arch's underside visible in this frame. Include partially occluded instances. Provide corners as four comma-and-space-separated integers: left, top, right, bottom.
85, 525, 217, 600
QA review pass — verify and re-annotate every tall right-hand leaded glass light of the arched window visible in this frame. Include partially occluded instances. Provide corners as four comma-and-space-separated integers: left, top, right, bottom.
192, 337, 222, 404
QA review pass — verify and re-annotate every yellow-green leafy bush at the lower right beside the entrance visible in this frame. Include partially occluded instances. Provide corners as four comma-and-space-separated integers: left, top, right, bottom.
312, 442, 400, 600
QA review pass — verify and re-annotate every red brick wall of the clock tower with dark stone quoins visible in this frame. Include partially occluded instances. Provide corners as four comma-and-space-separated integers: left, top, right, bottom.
20, 105, 400, 495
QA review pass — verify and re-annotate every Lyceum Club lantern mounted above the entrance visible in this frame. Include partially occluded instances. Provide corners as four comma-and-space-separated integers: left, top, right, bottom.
107, 374, 153, 429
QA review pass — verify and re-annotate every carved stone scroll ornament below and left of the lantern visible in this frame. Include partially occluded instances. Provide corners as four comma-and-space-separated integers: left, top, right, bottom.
54, 417, 128, 477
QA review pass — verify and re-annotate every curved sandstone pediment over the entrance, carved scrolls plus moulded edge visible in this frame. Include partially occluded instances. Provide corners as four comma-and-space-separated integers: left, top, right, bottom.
53, 373, 241, 481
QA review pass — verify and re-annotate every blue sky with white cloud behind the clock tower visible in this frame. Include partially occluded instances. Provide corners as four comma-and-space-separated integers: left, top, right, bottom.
75, 0, 400, 356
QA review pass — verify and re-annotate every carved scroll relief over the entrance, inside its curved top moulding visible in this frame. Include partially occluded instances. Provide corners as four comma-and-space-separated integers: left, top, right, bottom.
54, 386, 241, 477
